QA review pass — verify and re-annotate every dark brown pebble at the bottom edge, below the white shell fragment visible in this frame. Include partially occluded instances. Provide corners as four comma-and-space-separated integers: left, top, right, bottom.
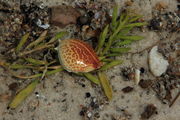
141, 104, 157, 119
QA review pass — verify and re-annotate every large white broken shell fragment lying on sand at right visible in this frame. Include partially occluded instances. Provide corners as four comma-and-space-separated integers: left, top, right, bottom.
149, 46, 169, 76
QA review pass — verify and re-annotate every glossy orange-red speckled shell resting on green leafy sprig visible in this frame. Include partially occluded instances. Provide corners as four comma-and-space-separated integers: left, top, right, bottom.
58, 39, 101, 73
